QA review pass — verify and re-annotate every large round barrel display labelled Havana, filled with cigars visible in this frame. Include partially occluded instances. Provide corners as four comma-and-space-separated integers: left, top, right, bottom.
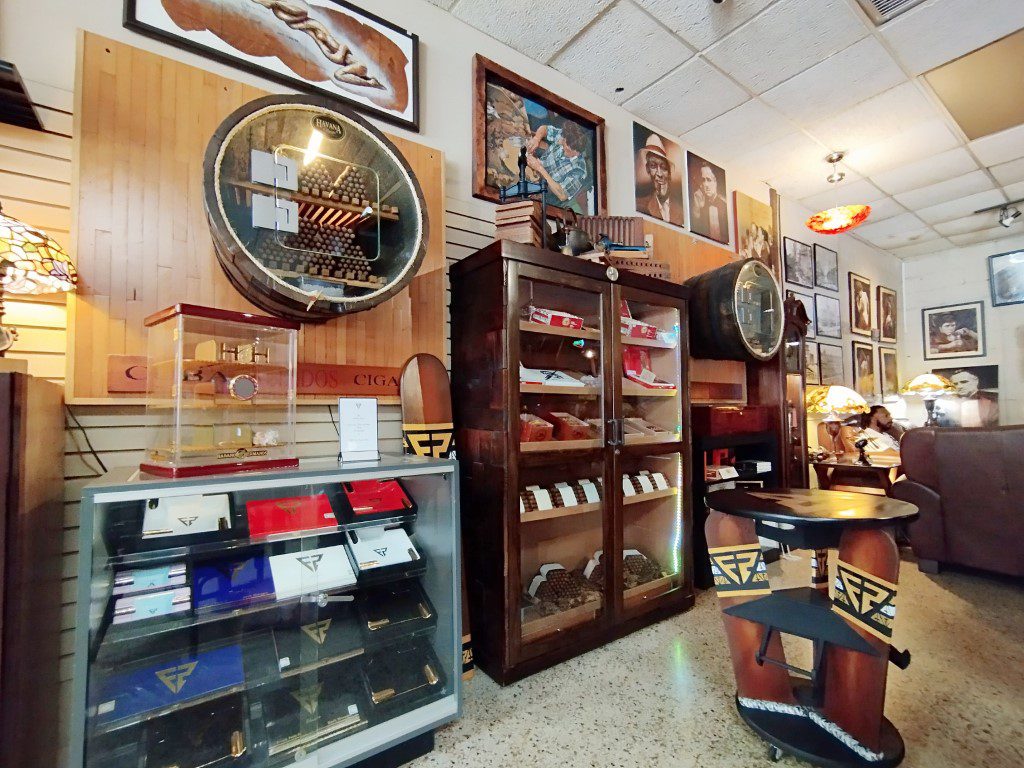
204, 95, 427, 323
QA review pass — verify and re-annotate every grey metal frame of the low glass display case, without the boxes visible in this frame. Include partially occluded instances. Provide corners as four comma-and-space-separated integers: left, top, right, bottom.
68, 456, 462, 768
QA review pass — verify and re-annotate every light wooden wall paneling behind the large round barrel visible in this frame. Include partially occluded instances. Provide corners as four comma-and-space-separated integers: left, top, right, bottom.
68, 33, 445, 403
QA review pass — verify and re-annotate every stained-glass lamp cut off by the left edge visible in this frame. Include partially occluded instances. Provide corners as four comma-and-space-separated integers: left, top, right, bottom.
0, 202, 78, 357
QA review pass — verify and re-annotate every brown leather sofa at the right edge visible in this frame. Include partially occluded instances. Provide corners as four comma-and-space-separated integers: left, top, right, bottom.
893, 426, 1024, 577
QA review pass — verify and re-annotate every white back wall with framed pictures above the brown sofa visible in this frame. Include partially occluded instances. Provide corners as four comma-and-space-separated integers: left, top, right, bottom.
900, 234, 1024, 426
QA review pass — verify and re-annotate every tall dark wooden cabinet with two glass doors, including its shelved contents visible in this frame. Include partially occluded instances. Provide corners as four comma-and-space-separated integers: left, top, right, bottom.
452, 241, 693, 683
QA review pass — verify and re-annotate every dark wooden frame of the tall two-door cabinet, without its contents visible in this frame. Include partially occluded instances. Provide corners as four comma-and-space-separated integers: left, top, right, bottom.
452, 241, 694, 684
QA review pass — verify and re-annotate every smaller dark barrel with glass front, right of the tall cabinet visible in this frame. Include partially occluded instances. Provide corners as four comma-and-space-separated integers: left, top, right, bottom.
686, 259, 785, 361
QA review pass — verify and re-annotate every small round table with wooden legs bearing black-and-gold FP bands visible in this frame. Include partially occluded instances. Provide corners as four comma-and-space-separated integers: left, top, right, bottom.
706, 488, 918, 768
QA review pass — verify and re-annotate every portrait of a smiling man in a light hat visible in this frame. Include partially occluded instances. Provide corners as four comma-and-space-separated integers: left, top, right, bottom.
633, 123, 686, 226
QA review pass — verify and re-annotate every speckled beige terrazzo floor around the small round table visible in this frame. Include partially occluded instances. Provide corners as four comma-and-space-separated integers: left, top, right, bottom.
412, 552, 1024, 768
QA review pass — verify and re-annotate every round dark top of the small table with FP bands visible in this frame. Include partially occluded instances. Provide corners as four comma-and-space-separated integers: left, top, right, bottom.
706, 488, 918, 527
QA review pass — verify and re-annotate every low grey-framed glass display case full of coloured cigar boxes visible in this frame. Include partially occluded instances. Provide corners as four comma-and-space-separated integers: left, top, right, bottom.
70, 457, 462, 768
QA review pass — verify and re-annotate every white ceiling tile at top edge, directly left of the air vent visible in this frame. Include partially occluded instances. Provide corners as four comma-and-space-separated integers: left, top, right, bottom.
707, 0, 867, 93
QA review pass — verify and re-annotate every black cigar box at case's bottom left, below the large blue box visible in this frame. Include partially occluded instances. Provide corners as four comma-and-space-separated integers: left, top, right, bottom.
145, 693, 252, 768
